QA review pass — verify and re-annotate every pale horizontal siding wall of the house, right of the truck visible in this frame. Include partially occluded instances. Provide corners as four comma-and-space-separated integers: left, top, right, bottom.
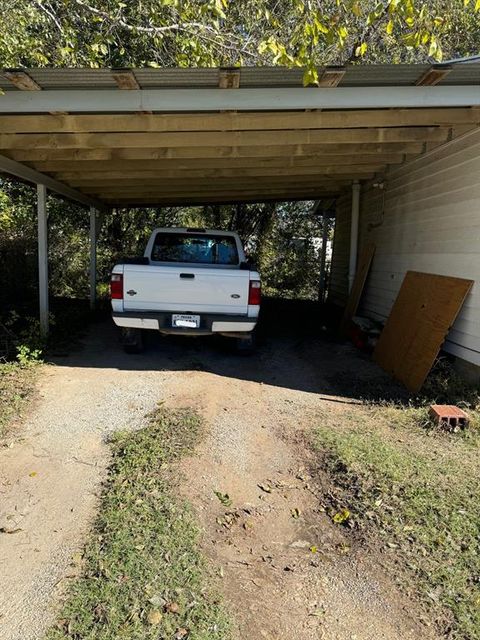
332, 130, 480, 366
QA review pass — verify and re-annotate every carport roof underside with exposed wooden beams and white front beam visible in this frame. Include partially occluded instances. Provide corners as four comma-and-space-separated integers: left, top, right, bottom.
0, 63, 480, 206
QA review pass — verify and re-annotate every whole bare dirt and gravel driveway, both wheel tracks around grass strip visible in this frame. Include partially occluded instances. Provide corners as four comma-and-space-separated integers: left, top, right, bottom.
0, 324, 440, 640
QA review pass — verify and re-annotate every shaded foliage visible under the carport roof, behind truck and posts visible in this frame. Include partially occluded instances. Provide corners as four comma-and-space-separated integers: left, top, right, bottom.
0, 180, 331, 318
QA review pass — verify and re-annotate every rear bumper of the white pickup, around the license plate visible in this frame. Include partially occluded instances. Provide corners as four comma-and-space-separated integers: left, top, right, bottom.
112, 311, 257, 335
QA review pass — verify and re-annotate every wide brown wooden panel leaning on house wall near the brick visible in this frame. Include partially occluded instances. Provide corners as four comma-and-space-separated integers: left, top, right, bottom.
374, 271, 473, 392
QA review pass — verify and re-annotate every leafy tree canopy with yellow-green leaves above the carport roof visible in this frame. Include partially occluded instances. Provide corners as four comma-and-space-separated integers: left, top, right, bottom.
0, 0, 480, 83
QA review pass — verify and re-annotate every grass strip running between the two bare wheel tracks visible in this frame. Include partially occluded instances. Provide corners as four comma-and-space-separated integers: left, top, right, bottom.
47, 409, 230, 640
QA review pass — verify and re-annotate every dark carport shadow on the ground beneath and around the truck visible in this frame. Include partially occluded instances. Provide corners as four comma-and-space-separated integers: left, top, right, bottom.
51, 300, 416, 403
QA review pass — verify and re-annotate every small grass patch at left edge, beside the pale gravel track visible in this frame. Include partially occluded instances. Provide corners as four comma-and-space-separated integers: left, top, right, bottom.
0, 362, 36, 438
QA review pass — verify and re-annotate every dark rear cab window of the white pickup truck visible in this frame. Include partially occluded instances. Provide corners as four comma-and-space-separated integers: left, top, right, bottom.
151, 233, 238, 265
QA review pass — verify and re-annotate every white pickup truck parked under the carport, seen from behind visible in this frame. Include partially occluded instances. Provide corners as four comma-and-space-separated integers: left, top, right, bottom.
110, 228, 261, 353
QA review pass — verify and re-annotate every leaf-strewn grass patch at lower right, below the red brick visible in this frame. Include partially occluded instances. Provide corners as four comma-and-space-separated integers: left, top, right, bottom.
315, 406, 480, 640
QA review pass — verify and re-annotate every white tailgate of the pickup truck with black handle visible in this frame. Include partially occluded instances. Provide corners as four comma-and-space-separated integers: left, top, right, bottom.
123, 265, 249, 314
